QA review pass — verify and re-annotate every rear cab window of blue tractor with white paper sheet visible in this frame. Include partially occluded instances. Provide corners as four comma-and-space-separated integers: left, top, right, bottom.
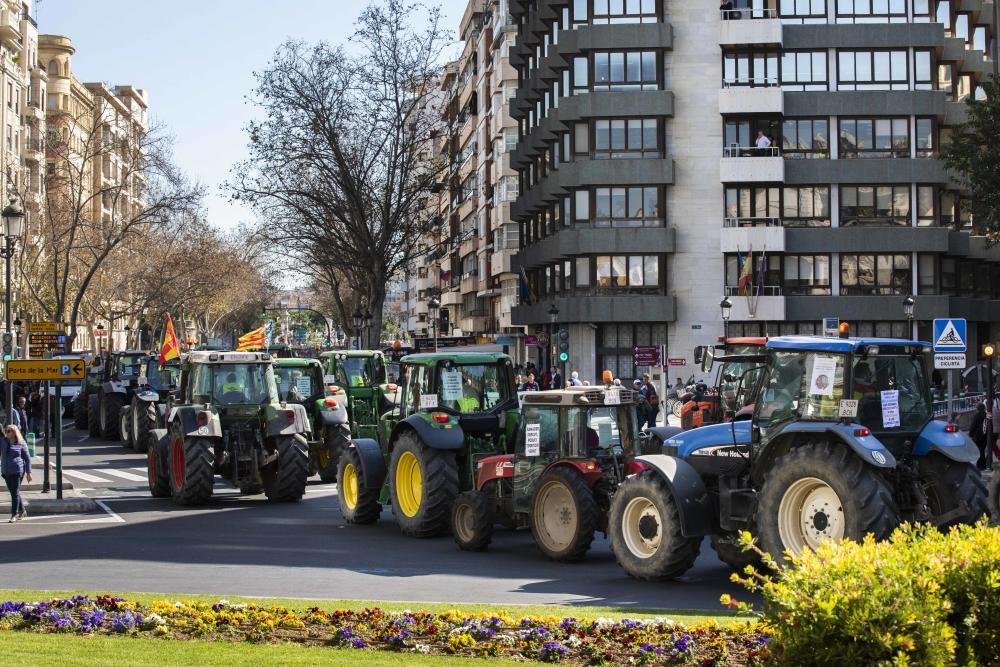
851, 355, 933, 431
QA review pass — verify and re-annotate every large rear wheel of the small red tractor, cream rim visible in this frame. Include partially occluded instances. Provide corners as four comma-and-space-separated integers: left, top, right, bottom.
531, 466, 598, 561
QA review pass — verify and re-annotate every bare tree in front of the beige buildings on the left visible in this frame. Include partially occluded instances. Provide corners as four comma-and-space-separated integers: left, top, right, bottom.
21, 92, 202, 345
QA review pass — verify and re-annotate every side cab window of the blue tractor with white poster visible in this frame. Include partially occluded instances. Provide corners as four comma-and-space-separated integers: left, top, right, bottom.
756, 351, 846, 429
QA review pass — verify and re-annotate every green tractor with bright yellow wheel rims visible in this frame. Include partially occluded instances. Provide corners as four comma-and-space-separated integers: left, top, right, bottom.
337, 352, 520, 537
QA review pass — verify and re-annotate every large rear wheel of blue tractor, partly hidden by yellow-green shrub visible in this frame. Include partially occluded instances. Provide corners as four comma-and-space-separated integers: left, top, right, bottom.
755, 442, 900, 564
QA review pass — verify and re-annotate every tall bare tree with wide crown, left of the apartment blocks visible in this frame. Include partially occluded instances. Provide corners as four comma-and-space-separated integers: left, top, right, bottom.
229, 0, 446, 344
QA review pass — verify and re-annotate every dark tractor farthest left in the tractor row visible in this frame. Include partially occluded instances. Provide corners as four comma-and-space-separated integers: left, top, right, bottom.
85, 350, 147, 445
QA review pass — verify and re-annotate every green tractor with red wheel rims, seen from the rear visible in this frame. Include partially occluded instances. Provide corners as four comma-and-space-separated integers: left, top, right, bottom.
146, 351, 310, 505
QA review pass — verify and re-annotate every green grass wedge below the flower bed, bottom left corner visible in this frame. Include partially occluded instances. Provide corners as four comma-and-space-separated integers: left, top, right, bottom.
0, 632, 530, 667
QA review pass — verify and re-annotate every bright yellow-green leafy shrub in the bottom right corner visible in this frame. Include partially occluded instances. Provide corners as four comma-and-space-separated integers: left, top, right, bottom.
723, 523, 1000, 665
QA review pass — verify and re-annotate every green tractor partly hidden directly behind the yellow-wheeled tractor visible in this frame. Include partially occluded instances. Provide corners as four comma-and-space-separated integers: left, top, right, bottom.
321, 350, 399, 439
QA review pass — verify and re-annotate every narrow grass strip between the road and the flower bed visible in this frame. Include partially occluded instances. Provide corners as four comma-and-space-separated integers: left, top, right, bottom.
0, 588, 743, 628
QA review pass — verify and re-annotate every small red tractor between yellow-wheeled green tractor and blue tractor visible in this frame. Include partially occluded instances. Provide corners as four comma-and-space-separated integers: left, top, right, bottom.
451, 384, 668, 561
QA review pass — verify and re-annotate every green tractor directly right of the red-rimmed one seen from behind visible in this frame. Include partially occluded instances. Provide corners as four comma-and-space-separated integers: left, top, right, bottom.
274, 357, 351, 482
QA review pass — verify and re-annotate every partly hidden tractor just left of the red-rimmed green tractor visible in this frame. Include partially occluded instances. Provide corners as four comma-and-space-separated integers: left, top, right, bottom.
119, 354, 181, 453
